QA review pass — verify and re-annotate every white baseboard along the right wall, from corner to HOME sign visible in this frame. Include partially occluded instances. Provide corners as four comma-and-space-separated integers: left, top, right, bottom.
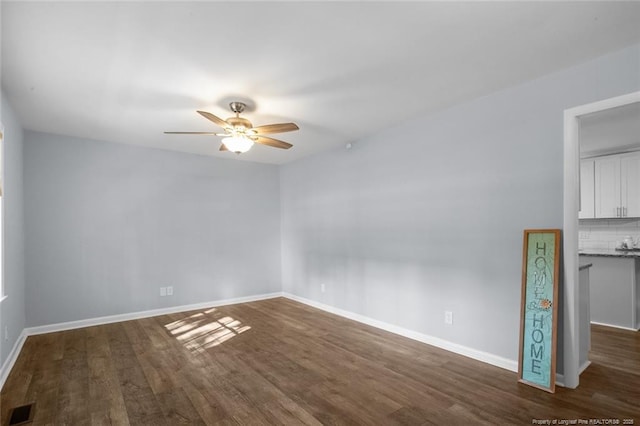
283, 292, 518, 372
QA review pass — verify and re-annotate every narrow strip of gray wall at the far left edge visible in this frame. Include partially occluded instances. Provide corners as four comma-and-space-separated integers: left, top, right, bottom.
0, 94, 25, 365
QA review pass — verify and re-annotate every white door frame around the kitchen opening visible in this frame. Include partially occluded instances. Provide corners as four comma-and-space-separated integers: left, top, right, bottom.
562, 91, 640, 388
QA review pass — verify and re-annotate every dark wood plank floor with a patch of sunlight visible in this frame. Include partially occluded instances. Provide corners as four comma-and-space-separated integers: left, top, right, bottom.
1, 298, 640, 426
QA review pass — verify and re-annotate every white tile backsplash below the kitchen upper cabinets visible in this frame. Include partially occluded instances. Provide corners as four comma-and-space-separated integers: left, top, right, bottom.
578, 218, 640, 249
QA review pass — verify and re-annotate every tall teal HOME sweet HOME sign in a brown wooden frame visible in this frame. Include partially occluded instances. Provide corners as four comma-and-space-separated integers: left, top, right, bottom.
518, 229, 562, 393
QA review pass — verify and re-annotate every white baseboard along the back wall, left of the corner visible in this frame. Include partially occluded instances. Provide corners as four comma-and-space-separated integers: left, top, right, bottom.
25, 292, 282, 336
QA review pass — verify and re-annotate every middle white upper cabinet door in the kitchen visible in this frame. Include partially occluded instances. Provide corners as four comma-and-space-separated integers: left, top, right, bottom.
595, 156, 621, 218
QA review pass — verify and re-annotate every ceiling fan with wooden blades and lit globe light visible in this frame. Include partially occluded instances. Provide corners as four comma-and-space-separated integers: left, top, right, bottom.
164, 102, 299, 154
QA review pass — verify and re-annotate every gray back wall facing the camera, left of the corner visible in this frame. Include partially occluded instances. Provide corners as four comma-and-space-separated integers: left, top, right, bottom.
24, 131, 281, 326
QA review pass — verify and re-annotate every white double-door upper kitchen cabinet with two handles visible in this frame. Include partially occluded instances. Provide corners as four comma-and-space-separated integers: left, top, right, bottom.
592, 152, 640, 218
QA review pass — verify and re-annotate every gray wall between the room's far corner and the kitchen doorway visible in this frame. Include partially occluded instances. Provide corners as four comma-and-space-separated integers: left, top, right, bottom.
280, 45, 640, 365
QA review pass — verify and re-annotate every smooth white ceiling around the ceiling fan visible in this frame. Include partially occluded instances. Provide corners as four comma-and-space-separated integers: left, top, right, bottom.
0, 1, 640, 164
